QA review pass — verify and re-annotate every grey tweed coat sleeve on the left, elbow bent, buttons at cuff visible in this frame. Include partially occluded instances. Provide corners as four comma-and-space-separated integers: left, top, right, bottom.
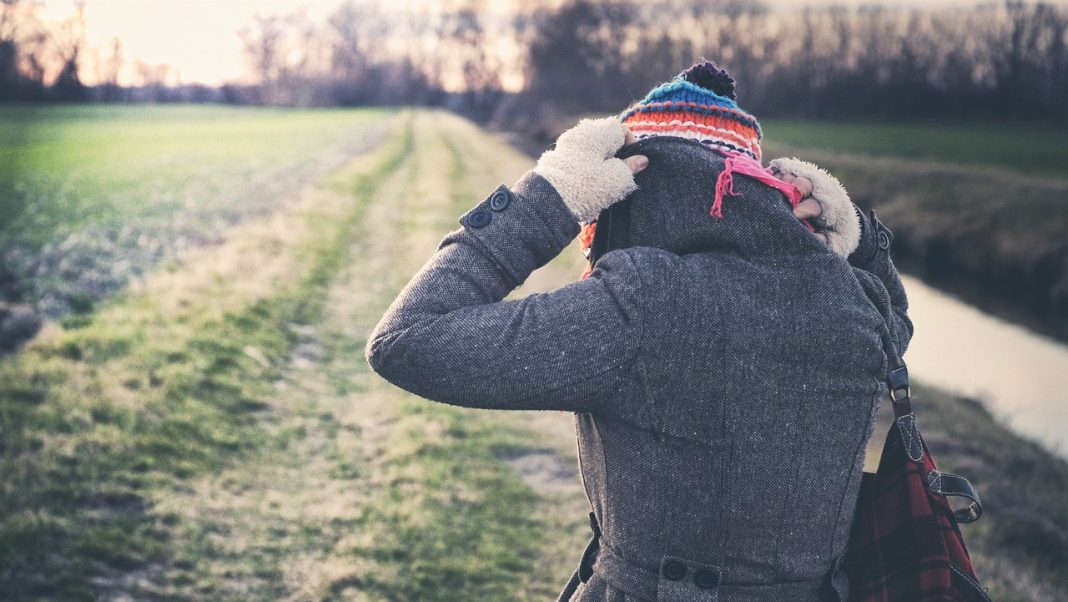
366, 172, 641, 412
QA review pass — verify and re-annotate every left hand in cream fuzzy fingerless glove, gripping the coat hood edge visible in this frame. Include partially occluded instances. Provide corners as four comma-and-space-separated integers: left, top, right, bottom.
534, 117, 649, 221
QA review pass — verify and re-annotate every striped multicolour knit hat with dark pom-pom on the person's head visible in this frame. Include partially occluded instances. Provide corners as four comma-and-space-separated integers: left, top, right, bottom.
619, 61, 761, 161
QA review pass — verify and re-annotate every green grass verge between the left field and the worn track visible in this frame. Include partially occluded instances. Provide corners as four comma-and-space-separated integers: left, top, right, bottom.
0, 111, 411, 600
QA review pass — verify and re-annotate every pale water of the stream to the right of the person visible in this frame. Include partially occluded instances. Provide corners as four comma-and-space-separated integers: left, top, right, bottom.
902, 276, 1068, 458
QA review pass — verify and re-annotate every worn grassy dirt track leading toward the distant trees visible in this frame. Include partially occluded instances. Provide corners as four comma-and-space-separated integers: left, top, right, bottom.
87, 113, 586, 600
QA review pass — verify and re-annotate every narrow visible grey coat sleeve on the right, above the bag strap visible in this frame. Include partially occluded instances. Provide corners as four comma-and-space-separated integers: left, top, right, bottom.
849, 209, 912, 354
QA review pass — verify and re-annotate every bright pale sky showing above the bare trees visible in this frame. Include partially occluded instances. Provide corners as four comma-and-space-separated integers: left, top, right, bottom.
33, 0, 1068, 85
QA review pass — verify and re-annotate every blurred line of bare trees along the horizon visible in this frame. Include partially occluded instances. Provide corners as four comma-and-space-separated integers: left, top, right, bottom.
0, 0, 1068, 127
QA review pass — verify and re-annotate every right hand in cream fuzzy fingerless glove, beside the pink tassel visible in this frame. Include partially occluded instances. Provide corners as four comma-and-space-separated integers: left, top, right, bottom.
770, 158, 861, 257
